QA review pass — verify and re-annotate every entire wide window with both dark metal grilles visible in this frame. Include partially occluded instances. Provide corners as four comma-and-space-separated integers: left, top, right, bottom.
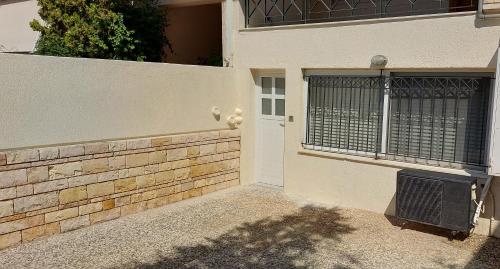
304, 73, 491, 167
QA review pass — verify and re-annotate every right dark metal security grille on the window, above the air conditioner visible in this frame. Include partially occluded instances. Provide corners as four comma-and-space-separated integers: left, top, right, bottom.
387, 76, 490, 166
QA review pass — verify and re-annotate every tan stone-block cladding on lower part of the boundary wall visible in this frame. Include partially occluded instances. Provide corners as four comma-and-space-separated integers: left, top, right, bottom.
0, 130, 240, 249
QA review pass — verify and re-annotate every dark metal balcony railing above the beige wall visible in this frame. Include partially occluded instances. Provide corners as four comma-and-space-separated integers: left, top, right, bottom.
245, 0, 478, 27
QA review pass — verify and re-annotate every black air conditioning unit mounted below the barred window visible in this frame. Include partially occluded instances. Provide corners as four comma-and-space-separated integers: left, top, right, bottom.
396, 170, 477, 233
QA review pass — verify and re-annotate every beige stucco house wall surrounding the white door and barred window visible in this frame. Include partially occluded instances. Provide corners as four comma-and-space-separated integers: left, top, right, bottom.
234, 4, 500, 236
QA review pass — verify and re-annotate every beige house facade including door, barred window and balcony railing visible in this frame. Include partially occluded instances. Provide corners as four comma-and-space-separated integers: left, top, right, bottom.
2, 0, 500, 236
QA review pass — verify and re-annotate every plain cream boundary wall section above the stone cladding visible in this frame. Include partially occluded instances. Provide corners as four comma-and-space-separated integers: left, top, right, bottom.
0, 54, 237, 149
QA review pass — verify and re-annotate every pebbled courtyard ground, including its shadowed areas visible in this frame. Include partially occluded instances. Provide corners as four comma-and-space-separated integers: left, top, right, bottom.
0, 186, 500, 269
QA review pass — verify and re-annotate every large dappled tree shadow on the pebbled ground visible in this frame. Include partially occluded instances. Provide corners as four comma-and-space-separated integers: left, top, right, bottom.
114, 206, 356, 269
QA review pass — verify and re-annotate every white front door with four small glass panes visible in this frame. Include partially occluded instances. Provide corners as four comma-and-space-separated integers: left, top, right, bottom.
256, 76, 285, 186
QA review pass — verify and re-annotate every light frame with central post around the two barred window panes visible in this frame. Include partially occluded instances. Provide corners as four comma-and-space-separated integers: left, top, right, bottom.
302, 70, 496, 171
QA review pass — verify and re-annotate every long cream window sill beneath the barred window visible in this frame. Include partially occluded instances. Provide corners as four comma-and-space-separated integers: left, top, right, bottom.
298, 147, 487, 178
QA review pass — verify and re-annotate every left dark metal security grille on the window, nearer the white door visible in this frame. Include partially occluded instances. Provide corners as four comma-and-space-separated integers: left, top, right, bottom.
305, 76, 385, 154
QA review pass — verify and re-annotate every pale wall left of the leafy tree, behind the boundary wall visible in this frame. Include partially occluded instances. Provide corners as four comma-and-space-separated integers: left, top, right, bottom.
0, 0, 39, 52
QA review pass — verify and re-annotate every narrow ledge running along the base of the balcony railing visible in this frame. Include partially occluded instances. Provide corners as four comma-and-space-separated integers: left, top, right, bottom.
239, 11, 477, 32
